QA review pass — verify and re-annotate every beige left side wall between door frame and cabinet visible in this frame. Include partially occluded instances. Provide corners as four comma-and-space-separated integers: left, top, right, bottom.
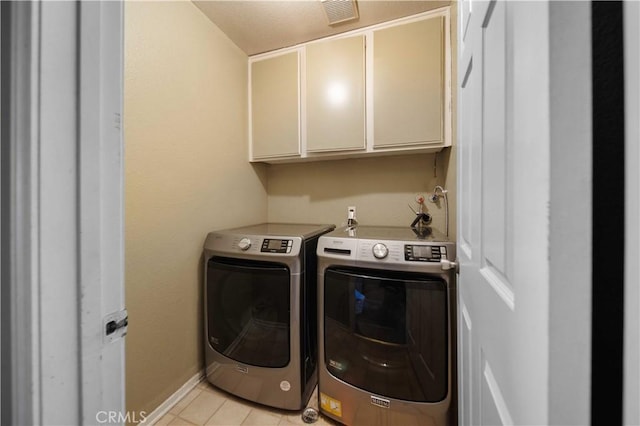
124, 1, 267, 413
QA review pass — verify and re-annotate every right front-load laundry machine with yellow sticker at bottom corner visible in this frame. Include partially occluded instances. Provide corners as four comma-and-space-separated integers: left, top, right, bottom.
318, 226, 457, 426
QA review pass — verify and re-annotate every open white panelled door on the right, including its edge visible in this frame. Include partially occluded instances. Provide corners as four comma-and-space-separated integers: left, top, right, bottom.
458, 0, 590, 425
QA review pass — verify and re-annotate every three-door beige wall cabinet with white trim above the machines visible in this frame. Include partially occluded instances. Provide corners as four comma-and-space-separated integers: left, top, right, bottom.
249, 7, 451, 163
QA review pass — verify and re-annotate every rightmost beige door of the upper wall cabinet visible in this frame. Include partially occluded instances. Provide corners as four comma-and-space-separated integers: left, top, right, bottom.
373, 16, 444, 148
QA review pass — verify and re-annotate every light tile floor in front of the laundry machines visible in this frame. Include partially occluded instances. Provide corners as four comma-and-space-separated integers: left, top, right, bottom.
155, 381, 339, 426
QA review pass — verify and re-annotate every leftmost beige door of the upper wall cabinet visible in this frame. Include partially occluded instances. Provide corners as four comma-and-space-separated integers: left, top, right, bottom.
250, 51, 300, 159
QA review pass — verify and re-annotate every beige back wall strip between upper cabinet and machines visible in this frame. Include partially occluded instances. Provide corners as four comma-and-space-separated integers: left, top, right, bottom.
268, 150, 455, 237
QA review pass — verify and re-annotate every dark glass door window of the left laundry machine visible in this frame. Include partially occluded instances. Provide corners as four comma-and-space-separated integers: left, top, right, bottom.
207, 257, 290, 368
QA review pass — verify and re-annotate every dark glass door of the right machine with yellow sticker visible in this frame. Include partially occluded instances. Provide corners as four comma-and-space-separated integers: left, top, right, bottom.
323, 267, 448, 402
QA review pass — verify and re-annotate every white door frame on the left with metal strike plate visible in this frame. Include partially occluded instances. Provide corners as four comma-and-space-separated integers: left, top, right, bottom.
1, 1, 125, 424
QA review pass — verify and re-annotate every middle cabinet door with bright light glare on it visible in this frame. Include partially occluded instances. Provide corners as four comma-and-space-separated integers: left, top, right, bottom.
305, 35, 365, 152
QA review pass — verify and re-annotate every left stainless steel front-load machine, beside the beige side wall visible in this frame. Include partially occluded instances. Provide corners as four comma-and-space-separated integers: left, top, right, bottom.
204, 223, 335, 410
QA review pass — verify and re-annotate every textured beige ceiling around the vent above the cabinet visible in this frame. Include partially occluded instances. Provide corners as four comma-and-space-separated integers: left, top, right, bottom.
193, 0, 450, 56
